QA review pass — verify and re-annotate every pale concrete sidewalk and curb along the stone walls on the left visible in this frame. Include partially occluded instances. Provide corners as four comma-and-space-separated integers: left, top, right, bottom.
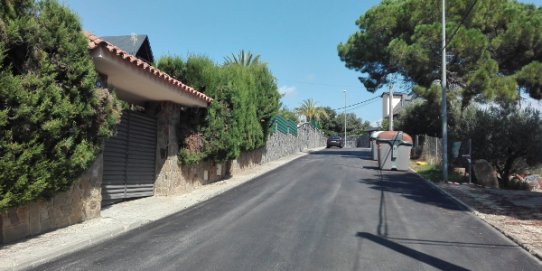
0, 147, 325, 271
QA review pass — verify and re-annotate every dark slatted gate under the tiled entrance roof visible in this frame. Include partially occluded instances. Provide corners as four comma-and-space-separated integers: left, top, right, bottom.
102, 111, 157, 205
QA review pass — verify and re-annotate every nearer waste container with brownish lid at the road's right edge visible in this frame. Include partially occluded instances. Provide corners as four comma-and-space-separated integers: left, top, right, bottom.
376, 131, 413, 170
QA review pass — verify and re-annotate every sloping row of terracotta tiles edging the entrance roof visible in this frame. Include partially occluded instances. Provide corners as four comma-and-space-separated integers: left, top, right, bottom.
84, 32, 213, 104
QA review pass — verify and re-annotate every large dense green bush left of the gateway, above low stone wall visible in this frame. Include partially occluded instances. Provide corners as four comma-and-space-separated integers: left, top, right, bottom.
0, 0, 120, 209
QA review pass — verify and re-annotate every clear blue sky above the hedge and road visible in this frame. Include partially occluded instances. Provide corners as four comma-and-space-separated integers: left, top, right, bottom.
60, 0, 542, 127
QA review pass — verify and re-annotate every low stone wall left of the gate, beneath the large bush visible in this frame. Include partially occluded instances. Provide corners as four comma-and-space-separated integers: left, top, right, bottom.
0, 154, 103, 243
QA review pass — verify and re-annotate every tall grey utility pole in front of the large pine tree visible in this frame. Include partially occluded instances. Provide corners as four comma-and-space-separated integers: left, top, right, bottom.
440, 0, 448, 182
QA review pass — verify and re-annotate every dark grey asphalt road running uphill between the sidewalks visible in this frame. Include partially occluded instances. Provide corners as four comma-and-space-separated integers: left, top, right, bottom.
35, 149, 542, 271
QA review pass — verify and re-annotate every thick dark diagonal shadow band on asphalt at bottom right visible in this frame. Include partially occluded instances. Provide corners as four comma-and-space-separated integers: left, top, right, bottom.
356, 232, 469, 270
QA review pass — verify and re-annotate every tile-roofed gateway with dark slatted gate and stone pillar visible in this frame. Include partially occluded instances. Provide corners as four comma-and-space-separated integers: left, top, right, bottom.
85, 33, 212, 205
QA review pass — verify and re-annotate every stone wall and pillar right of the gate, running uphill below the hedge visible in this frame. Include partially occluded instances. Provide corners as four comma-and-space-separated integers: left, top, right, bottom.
155, 120, 326, 196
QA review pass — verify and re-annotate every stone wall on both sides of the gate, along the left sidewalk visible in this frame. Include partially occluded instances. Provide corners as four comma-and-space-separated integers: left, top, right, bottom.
0, 110, 326, 243
